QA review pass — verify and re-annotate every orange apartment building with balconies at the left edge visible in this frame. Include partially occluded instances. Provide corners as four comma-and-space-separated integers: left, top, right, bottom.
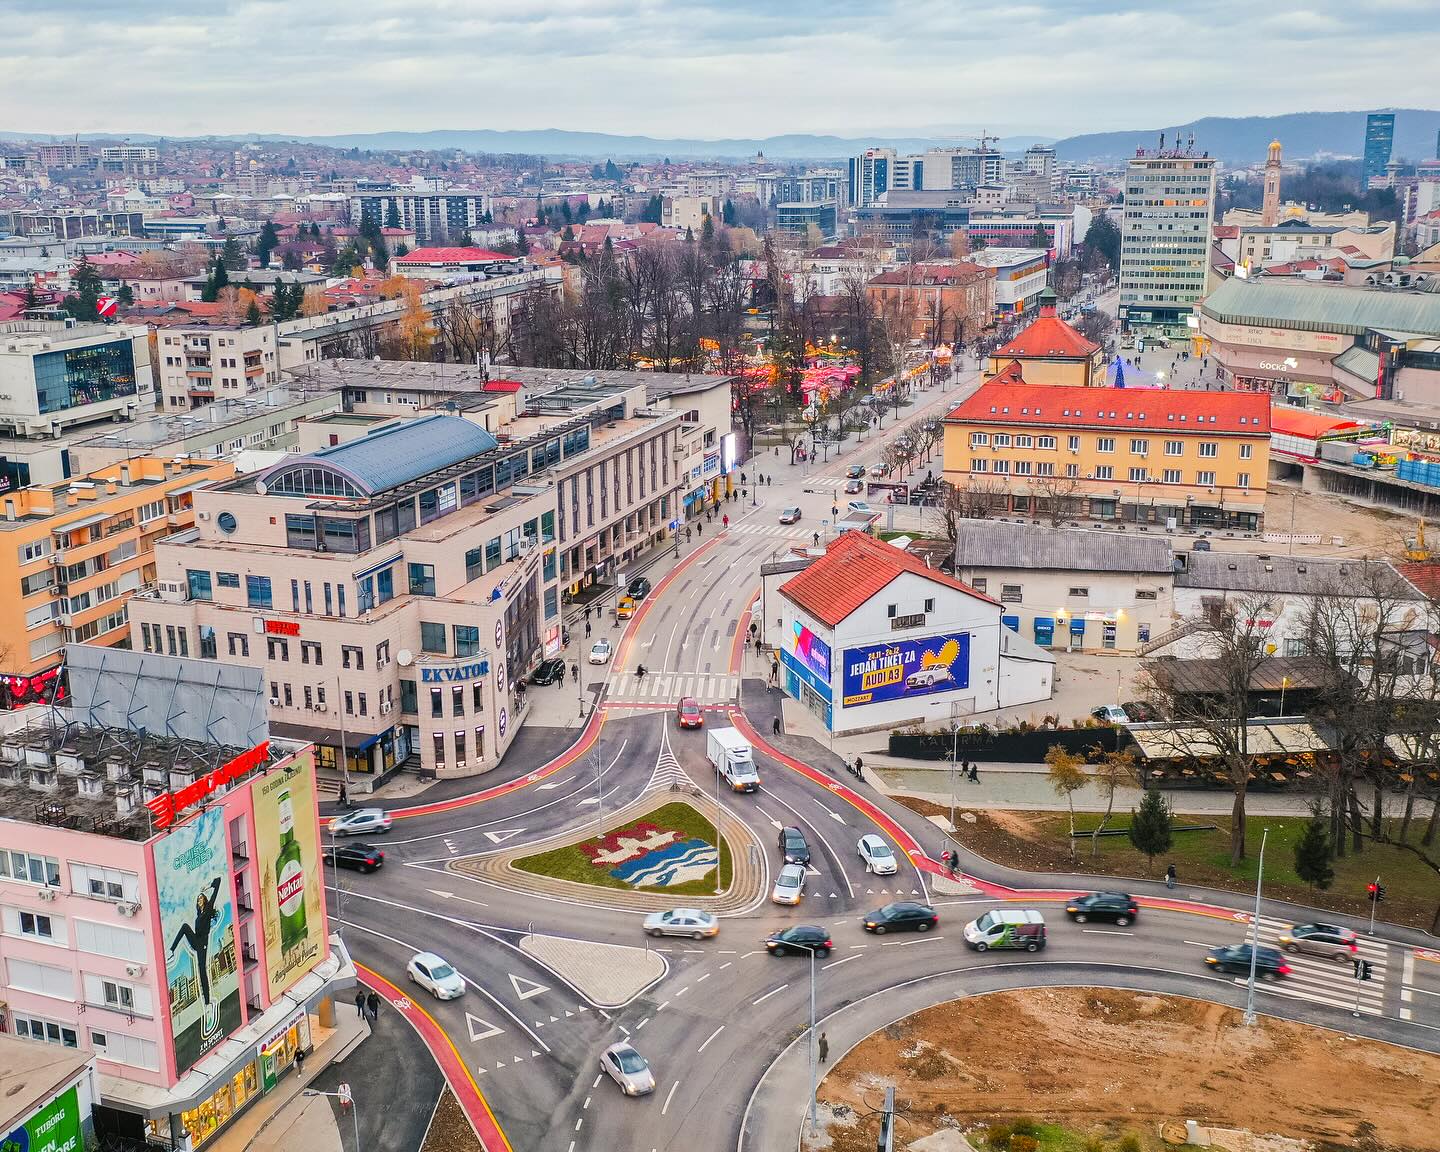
0, 456, 235, 708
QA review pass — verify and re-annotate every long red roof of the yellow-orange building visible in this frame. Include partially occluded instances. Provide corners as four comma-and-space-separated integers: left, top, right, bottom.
945, 380, 1270, 435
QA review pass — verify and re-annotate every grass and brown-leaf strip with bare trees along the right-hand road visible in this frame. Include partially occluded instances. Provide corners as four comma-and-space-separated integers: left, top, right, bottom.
906, 799, 1440, 929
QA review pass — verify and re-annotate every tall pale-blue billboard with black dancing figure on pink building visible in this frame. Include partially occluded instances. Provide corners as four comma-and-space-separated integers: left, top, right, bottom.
154, 805, 240, 1076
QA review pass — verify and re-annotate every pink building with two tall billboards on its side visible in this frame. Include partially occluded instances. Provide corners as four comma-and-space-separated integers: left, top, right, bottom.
0, 719, 354, 1149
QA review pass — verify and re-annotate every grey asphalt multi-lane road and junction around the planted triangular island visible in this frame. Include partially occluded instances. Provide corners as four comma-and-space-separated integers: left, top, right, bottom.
330, 367, 1440, 1152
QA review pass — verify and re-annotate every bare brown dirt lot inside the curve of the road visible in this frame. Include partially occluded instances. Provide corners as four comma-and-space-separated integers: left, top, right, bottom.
808, 988, 1440, 1152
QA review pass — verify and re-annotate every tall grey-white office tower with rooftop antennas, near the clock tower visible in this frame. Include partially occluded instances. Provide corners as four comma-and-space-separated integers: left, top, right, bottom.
1120, 135, 1215, 334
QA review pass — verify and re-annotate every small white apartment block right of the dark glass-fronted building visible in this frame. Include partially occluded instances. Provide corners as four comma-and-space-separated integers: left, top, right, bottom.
156, 318, 279, 412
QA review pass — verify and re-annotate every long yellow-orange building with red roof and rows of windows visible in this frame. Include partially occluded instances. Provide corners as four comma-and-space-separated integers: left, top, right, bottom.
945, 364, 1270, 531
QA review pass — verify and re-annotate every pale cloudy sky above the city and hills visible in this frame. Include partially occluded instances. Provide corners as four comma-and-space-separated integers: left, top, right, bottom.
0, 0, 1440, 137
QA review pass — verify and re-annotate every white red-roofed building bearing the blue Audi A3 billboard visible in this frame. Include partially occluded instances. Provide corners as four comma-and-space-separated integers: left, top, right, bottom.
768, 531, 1054, 734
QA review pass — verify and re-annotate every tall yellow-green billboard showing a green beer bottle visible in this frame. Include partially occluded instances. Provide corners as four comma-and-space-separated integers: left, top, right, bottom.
259, 752, 325, 1001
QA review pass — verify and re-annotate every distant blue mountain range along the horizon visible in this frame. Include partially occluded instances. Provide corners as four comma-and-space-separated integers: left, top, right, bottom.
8, 108, 1440, 167
